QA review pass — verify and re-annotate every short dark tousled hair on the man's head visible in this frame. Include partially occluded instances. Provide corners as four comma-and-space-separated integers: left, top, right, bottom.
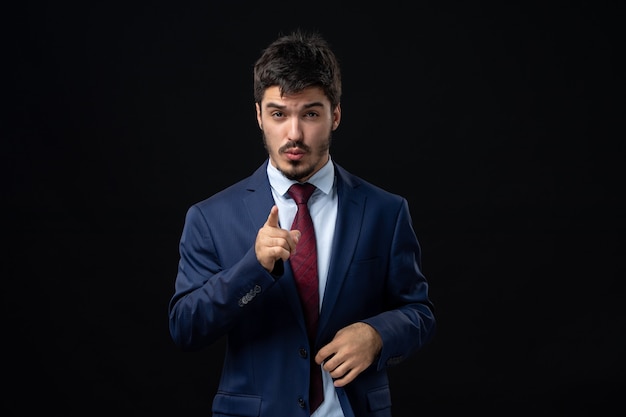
254, 30, 341, 108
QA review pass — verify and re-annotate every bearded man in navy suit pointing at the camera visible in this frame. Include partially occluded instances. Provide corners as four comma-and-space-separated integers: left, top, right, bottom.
169, 31, 435, 417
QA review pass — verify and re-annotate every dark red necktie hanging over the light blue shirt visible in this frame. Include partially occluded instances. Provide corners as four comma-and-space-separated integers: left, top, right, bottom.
288, 182, 324, 413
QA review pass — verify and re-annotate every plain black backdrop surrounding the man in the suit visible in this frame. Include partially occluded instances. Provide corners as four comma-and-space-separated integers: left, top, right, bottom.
0, 1, 626, 417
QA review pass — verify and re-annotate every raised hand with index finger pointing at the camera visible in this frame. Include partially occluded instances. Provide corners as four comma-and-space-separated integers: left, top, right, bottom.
254, 205, 300, 272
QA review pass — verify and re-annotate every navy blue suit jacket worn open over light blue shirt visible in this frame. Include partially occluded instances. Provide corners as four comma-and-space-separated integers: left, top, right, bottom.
169, 160, 435, 417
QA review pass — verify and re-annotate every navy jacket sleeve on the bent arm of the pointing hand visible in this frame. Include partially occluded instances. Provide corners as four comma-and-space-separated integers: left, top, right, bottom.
169, 206, 275, 350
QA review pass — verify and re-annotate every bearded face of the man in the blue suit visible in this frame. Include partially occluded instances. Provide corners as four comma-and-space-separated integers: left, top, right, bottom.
256, 86, 341, 182
